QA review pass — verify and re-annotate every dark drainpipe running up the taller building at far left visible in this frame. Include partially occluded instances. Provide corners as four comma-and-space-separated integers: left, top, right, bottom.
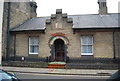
6, 2, 11, 61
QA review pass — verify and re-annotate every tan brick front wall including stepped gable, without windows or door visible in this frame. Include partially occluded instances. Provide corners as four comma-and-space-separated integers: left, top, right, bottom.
10, 13, 114, 62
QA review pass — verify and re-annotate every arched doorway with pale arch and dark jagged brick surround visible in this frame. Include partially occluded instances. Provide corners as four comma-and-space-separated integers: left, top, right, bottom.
48, 35, 69, 62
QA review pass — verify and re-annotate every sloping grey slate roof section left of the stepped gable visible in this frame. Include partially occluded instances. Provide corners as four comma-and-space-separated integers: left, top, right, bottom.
11, 17, 48, 31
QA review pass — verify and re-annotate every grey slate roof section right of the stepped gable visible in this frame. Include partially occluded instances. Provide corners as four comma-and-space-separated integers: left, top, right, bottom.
71, 14, 119, 28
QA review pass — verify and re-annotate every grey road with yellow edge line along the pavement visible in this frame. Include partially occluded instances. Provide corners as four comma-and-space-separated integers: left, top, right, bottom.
15, 73, 109, 81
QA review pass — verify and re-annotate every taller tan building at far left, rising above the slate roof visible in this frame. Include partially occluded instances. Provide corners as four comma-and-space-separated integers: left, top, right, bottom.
2, 2, 37, 59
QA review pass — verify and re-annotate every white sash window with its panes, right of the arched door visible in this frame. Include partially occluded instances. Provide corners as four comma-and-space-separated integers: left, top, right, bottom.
81, 35, 93, 55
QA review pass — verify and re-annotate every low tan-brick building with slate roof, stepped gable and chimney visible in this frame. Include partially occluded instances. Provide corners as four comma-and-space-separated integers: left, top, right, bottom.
2, 0, 120, 62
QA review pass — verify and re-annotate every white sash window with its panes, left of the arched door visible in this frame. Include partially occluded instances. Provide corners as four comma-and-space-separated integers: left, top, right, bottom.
29, 37, 39, 54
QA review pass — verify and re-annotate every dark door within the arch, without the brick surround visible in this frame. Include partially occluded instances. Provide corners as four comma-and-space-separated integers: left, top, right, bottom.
54, 39, 65, 61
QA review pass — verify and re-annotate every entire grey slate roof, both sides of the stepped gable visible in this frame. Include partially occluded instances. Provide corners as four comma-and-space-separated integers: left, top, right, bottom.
11, 13, 120, 31
